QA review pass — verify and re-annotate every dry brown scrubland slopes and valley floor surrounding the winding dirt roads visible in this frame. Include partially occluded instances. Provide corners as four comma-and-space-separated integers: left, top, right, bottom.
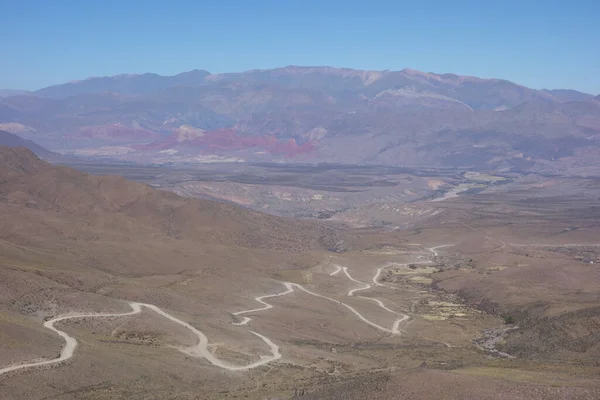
0, 148, 600, 399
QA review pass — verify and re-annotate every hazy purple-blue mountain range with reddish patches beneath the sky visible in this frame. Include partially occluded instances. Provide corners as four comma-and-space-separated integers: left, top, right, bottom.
0, 66, 600, 172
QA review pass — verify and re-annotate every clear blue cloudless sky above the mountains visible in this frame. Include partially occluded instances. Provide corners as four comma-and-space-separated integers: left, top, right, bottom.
0, 0, 600, 94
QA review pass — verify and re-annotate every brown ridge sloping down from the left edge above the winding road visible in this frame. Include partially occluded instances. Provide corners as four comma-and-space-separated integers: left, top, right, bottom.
0, 147, 337, 251
